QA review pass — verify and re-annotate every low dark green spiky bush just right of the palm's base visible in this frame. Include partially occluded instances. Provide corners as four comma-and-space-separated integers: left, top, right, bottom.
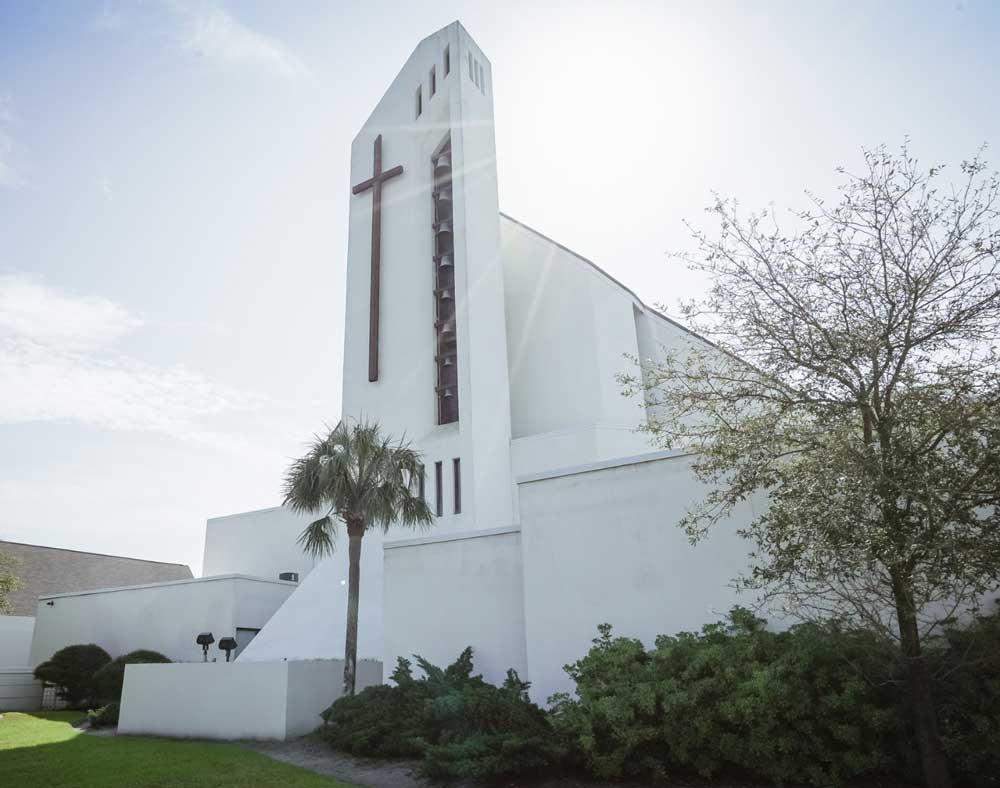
320, 648, 559, 778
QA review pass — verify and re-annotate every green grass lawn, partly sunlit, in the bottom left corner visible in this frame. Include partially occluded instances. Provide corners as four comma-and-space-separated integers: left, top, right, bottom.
0, 711, 360, 788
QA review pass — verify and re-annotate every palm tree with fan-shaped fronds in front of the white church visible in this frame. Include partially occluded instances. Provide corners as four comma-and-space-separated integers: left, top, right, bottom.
284, 421, 434, 695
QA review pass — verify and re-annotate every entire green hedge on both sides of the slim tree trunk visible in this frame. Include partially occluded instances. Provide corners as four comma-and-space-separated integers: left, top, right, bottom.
550, 608, 1000, 788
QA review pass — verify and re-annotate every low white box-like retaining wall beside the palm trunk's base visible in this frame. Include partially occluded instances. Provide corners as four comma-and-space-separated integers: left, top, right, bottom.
118, 659, 382, 739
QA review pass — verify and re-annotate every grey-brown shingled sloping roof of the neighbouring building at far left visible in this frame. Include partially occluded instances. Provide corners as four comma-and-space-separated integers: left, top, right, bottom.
0, 540, 194, 616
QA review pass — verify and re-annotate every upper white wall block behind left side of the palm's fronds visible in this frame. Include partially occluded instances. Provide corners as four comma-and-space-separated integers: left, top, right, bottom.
202, 506, 317, 581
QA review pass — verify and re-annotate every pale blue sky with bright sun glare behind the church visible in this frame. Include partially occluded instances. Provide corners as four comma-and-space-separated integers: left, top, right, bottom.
0, 0, 1000, 574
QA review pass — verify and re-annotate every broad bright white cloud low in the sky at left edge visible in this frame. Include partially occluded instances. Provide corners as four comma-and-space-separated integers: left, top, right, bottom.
0, 276, 259, 443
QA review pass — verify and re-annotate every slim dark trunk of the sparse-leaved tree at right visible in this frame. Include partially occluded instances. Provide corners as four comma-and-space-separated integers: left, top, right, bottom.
893, 576, 951, 788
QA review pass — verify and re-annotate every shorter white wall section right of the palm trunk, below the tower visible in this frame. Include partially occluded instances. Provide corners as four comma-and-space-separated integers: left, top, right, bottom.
383, 529, 526, 683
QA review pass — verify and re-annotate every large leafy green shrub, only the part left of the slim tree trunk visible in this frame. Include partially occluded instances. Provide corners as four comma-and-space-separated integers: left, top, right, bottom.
552, 609, 905, 785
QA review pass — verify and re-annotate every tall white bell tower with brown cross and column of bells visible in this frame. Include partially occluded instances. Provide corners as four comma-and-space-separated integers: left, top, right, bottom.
343, 22, 515, 538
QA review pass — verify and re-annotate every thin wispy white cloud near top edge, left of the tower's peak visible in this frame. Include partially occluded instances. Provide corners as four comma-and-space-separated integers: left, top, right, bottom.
181, 6, 308, 78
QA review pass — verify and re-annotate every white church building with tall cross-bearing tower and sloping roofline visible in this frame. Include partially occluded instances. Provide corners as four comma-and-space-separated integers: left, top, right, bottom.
11, 22, 762, 728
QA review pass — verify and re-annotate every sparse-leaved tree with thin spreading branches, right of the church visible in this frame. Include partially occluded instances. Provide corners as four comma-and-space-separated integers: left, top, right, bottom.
623, 146, 1000, 788
